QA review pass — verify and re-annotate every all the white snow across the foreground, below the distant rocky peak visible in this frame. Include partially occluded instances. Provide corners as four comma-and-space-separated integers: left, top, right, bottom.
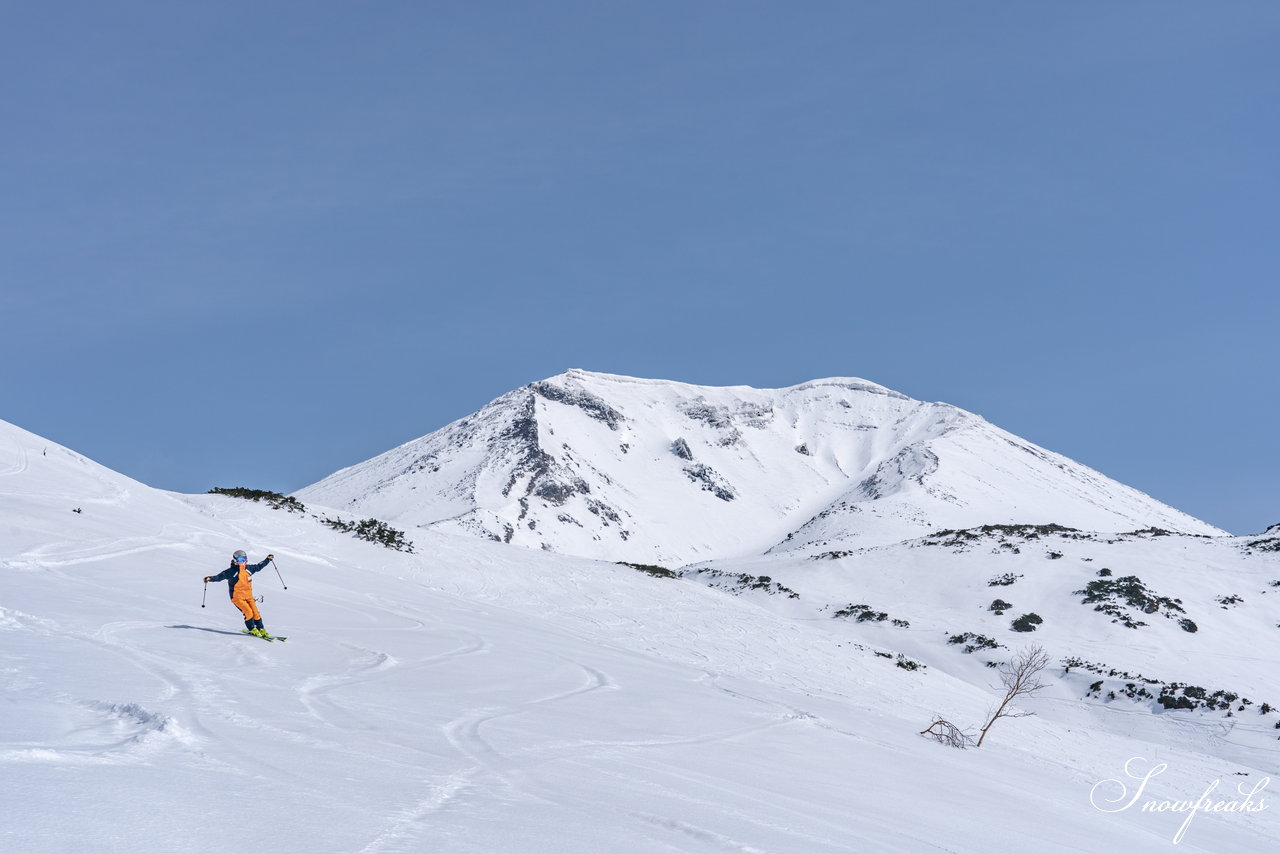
0, 423, 1280, 854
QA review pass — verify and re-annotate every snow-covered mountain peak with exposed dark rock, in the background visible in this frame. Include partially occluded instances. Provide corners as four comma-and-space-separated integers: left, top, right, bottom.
298, 370, 1222, 565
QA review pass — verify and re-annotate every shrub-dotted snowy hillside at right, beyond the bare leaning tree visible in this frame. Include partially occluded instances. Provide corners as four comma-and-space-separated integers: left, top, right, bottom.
701, 526, 1280, 737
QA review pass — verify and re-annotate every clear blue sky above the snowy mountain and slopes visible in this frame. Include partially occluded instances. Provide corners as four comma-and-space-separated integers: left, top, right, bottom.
0, 0, 1280, 534
